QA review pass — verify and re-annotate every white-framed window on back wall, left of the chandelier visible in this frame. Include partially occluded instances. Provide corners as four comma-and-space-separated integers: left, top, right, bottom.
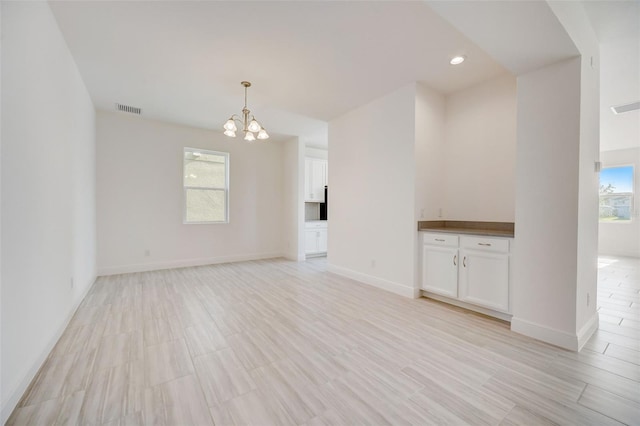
183, 148, 229, 223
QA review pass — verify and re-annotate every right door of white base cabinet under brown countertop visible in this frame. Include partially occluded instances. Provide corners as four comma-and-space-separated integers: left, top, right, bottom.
460, 250, 509, 312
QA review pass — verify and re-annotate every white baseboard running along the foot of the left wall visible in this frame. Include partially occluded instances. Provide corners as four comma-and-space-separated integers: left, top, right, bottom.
0, 276, 97, 425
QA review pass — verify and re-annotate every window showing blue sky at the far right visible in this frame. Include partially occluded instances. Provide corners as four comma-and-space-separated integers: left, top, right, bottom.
600, 166, 633, 223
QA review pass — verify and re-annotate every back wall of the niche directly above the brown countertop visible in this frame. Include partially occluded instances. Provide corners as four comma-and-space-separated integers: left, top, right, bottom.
440, 74, 517, 222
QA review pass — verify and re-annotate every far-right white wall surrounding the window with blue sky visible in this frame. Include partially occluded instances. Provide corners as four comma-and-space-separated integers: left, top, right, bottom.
598, 148, 640, 257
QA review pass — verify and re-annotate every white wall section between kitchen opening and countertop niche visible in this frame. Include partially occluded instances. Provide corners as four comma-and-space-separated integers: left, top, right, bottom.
328, 84, 416, 297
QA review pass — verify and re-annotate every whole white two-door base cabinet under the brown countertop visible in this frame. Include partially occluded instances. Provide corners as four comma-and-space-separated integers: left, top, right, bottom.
421, 232, 510, 313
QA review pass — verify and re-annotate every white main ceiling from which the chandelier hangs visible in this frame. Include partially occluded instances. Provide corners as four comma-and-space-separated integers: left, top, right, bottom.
51, 1, 506, 144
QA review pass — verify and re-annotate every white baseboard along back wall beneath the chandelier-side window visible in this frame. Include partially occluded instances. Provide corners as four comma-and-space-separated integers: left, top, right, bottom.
98, 252, 283, 277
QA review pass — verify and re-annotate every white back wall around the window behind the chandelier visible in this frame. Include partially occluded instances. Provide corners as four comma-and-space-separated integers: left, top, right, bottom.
97, 111, 283, 275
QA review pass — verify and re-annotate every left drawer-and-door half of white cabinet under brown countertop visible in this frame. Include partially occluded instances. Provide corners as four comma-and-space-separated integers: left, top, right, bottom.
422, 233, 458, 298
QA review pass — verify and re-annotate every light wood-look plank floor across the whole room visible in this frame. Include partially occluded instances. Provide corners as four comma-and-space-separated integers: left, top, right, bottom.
8, 255, 640, 426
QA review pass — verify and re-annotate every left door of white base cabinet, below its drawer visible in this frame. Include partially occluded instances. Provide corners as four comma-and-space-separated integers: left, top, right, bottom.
422, 245, 458, 298
